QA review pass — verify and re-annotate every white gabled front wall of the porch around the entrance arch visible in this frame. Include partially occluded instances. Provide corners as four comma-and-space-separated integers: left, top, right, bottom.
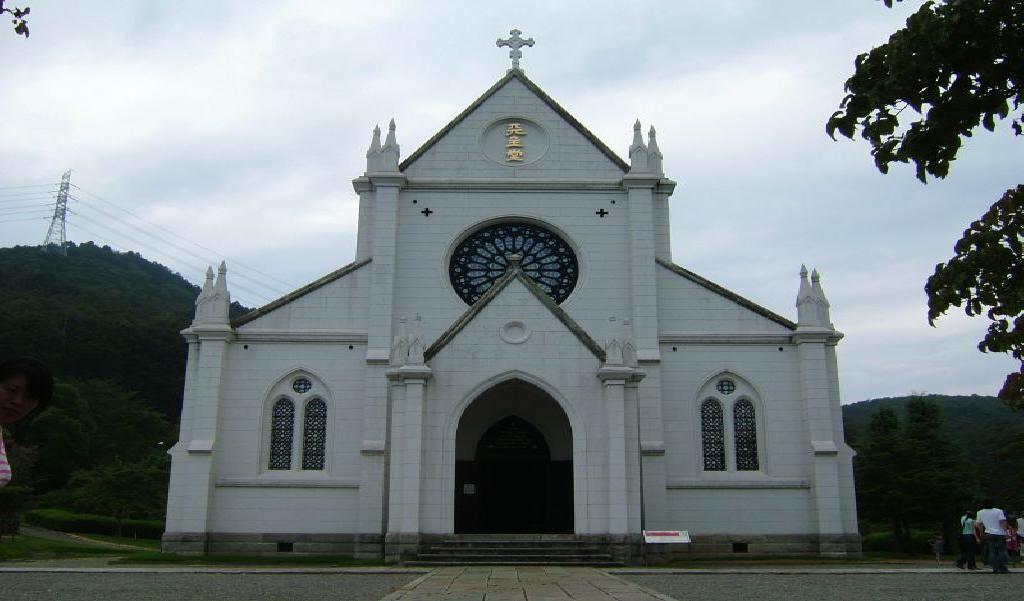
422, 282, 607, 533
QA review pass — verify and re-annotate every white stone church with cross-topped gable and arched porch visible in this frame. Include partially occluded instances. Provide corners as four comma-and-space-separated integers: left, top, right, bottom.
163, 31, 860, 561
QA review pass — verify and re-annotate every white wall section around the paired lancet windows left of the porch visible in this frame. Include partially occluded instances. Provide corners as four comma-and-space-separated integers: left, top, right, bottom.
203, 336, 366, 532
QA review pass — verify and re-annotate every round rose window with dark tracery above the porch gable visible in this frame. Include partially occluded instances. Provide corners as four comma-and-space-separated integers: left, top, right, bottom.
449, 222, 580, 305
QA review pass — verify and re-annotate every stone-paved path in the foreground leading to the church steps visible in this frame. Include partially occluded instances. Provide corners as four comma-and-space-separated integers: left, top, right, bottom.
383, 566, 672, 601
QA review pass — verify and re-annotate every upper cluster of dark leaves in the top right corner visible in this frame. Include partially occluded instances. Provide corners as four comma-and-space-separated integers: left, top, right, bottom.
826, 0, 1024, 181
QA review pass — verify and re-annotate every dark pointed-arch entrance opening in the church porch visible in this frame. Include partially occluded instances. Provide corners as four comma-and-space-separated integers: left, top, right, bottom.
455, 380, 572, 533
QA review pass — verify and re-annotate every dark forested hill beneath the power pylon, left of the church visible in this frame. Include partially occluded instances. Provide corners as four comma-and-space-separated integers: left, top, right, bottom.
0, 243, 246, 421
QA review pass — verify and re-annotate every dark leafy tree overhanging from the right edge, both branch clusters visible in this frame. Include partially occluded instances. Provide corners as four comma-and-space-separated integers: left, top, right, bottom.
826, 0, 1024, 407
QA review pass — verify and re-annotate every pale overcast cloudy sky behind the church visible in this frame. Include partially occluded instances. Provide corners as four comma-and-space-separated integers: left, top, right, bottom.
0, 0, 1021, 402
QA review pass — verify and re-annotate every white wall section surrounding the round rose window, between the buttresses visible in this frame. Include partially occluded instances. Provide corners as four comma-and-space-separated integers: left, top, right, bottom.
394, 190, 629, 341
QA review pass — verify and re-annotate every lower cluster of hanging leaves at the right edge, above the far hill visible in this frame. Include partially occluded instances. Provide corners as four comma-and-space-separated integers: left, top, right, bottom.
925, 185, 1024, 409
